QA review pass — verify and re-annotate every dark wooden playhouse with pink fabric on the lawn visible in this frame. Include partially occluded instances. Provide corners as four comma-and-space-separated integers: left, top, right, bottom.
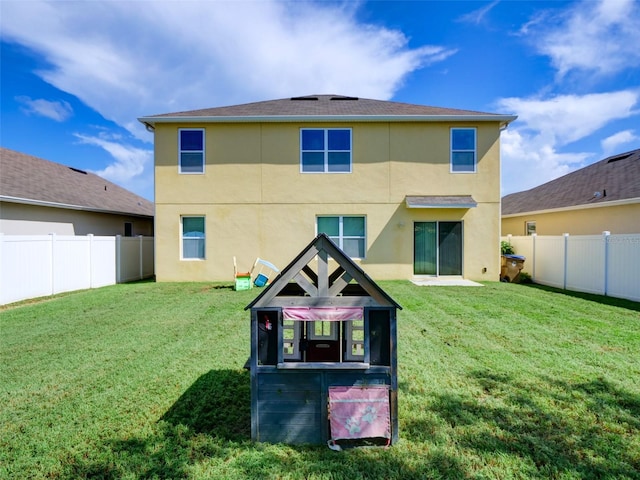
245, 234, 402, 448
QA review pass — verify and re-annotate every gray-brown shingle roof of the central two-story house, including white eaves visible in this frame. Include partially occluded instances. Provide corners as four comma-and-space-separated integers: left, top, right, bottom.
138, 95, 516, 127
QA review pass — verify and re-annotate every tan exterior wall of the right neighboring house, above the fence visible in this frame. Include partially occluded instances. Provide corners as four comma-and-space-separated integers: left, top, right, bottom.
502, 203, 640, 235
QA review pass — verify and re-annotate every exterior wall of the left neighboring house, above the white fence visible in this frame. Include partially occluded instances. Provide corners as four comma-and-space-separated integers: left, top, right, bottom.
0, 202, 153, 236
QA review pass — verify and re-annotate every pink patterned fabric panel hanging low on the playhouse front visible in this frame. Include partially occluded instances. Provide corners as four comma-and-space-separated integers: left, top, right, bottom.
329, 385, 391, 440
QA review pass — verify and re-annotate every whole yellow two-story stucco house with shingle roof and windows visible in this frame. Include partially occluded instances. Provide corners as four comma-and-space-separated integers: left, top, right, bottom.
139, 95, 516, 281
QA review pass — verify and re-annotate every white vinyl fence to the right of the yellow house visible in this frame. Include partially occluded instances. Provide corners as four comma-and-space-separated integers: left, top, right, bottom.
502, 232, 640, 302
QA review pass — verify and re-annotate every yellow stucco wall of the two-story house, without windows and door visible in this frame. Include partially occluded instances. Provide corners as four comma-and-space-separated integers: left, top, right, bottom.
155, 122, 500, 281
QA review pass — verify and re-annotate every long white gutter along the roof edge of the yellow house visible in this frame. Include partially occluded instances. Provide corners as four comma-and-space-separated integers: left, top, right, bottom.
138, 115, 518, 126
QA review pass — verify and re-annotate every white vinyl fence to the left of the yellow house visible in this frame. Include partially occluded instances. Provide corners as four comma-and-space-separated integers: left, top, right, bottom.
0, 234, 154, 305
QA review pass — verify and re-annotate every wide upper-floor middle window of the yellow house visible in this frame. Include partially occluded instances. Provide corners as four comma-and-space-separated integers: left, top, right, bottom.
300, 128, 351, 173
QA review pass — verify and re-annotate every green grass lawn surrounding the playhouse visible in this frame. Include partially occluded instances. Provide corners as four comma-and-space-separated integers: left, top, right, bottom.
0, 281, 640, 479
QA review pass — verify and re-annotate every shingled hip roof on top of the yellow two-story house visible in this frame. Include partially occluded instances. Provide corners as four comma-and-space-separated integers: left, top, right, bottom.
139, 95, 515, 123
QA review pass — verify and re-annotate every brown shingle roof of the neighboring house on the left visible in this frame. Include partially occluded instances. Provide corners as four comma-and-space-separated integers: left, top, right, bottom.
0, 147, 154, 217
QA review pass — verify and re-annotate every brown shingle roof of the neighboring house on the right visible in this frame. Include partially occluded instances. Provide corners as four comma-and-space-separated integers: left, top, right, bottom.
502, 149, 640, 217
